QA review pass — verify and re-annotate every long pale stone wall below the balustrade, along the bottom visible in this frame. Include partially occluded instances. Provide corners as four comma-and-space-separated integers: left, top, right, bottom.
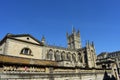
0, 70, 111, 80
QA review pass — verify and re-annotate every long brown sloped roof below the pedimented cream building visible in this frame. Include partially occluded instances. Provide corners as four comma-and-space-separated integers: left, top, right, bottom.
0, 54, 57, 66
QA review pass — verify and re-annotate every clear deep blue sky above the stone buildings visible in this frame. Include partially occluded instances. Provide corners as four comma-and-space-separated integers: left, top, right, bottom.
0, 0, 120, 54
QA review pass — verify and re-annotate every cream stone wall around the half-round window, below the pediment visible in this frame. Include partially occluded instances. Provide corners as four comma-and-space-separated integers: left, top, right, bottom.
5, 39, 42, 59
